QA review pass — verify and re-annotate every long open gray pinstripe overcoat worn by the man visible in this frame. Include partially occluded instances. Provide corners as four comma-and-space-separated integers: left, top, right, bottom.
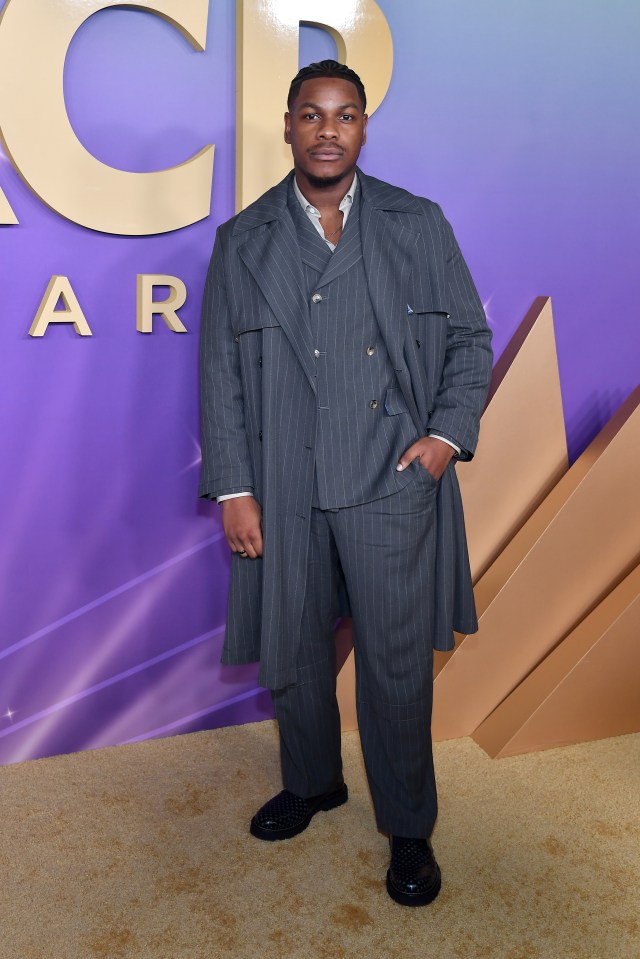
200, 171, 491, 689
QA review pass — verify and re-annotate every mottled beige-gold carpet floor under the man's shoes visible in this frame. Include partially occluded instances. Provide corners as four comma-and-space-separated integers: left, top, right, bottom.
0, 722, 640, 959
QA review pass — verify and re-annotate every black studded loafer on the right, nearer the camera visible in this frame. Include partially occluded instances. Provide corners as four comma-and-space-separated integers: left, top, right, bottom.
387, 836, 442, 906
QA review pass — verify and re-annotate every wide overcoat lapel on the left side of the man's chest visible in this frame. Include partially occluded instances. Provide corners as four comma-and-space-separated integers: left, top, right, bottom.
234, 175, 316, 392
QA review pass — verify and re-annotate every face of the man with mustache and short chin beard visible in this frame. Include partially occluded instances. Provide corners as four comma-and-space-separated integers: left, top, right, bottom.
284, 77, 367, 187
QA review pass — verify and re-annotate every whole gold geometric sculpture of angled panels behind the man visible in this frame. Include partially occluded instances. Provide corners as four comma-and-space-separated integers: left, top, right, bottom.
338, 298, 640, 756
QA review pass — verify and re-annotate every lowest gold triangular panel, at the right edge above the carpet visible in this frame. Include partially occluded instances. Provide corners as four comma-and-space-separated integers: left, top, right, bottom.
473, 566, 640, 757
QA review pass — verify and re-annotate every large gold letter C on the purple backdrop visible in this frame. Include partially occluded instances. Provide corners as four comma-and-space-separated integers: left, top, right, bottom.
0, 0, 214, 236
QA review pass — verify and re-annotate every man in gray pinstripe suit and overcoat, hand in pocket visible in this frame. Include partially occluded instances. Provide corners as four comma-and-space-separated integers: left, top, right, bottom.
200, 60, 491, 905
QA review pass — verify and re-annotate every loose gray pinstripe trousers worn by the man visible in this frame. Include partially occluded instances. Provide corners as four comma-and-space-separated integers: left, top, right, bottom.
272, 462, 437, 837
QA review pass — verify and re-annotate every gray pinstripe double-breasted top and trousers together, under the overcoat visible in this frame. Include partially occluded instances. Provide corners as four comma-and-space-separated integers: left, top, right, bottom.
273, 188, 437, 836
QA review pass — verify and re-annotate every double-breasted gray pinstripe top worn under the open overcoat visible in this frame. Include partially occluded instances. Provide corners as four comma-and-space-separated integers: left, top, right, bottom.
289, 189, 419, 509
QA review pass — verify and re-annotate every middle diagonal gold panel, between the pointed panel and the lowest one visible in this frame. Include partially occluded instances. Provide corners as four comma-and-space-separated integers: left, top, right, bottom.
433, 388, 640, 739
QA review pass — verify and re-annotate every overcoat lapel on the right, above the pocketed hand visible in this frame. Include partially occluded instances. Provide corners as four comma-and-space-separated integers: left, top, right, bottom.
358, 171, 421, 428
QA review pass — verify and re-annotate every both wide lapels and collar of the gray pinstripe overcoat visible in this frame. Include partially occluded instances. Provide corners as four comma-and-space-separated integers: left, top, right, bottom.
233, 170, 422, 421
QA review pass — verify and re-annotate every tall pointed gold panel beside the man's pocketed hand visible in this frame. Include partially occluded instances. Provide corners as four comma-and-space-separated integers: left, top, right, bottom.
458, 297, 569, 582
